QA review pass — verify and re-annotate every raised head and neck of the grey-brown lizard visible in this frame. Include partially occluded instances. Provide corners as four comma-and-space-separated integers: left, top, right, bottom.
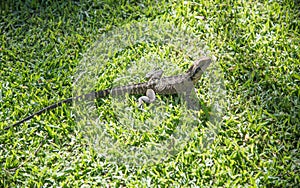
187, 57, 211, 84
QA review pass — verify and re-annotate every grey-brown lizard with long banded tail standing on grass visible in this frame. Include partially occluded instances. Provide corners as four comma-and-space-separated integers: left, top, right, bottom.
4, 57, 212, 130
